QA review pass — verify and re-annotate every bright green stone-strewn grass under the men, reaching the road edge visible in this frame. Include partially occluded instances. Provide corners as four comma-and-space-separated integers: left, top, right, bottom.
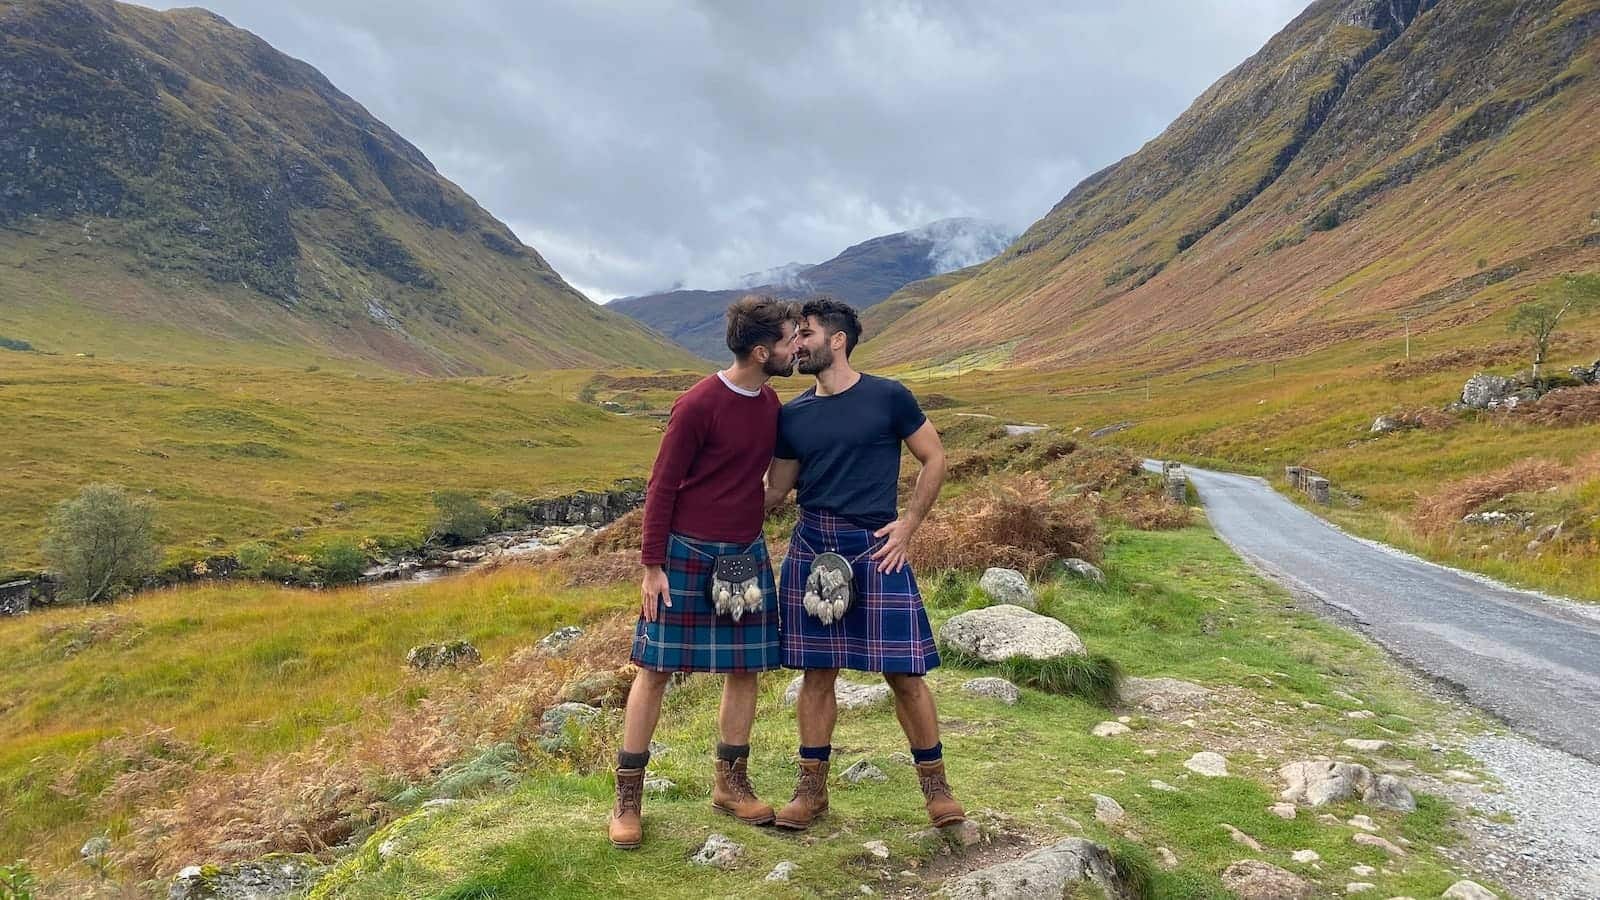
302, 527, 1497, 898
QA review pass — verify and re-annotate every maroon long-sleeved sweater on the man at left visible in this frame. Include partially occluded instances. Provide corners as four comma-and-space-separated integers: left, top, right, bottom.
643, 373, 782, 565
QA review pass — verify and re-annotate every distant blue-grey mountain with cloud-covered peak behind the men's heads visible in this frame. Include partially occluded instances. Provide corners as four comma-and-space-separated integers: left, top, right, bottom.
608, 218, 1014, 360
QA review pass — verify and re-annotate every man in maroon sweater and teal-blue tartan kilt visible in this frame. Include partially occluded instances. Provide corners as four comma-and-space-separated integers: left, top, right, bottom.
610, 296, 798, 849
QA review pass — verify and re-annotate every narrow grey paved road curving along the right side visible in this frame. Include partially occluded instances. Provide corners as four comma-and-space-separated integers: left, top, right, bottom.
1146, 461, 1600, 762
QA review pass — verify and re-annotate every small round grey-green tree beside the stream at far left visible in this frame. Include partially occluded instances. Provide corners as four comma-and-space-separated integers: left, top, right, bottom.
43, 484, 160, 602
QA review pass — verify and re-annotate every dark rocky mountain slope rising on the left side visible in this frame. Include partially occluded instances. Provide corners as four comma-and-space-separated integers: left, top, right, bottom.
0, 0, 693, 373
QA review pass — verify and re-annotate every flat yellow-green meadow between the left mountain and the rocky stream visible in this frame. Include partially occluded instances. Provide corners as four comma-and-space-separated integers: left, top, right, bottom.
0, 351, 691, 569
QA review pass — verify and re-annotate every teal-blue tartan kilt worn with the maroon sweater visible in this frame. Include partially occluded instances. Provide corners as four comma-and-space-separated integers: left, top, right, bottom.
632, 535, 779, 673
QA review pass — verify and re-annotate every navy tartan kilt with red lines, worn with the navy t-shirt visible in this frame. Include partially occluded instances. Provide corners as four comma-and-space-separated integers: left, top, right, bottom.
778, 511, 939, 674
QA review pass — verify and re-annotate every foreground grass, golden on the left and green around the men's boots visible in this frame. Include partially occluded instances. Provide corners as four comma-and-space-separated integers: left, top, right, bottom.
0, 527, 1504, 898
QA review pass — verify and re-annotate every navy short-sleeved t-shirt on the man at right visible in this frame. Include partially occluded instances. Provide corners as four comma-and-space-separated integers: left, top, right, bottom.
776, 375, 928, 528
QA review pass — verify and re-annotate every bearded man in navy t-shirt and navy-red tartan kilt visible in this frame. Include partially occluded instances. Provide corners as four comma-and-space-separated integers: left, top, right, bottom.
766, 298, 965, 830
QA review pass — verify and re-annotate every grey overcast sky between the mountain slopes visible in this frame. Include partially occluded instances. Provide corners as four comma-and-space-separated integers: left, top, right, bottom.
149, 0, 1304, 301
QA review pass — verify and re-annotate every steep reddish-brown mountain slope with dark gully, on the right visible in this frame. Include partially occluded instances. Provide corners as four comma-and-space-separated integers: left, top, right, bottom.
862, 0, 1600, 367
